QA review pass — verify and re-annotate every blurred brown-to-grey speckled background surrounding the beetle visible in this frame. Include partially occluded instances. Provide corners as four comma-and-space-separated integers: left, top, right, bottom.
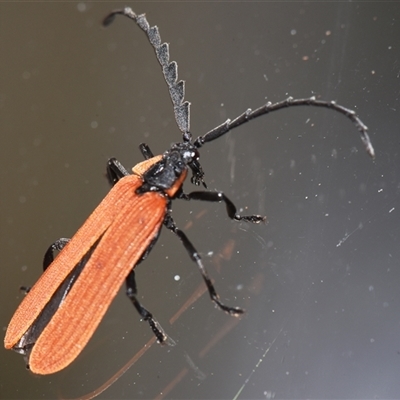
0, 2, 400, 399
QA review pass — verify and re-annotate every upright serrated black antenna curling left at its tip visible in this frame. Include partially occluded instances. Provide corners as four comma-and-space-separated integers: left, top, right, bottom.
103, 7, 191, 142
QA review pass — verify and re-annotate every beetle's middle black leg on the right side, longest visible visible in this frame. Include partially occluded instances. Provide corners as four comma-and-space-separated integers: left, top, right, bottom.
164, 215, 244, 317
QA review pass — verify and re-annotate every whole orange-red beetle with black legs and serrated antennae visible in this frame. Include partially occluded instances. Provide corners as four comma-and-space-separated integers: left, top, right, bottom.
4, 8, 375, 374
